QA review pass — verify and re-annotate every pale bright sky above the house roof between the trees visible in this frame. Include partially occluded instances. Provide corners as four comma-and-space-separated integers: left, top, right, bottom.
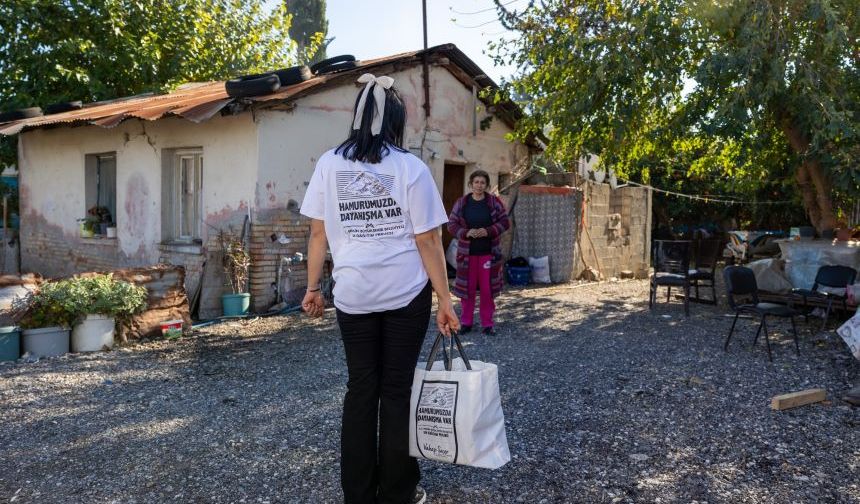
292, 0, 528, 83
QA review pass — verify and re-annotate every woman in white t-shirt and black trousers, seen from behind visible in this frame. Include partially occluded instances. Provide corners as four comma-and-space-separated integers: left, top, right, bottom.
301, 74, 460, 504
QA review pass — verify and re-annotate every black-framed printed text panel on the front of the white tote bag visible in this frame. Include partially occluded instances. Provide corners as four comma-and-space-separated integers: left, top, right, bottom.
415, 380, 460, 464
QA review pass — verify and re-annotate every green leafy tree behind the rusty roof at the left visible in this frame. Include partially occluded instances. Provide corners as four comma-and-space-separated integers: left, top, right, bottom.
0, 0, 308, 163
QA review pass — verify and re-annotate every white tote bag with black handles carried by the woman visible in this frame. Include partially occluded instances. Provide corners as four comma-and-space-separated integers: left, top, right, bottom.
409, 334, 511, 469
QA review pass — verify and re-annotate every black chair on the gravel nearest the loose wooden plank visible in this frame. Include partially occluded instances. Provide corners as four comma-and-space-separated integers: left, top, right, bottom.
723, 266, 800, 361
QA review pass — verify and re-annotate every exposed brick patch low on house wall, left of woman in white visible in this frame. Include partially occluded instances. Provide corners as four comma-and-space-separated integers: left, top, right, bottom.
250, 208, 310, 312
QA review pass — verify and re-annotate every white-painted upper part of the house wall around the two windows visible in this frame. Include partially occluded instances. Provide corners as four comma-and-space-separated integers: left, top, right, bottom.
19, 114, 258, 262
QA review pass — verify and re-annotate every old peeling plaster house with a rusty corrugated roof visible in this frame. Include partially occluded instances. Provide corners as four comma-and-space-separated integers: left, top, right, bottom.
0, 45, 533, 318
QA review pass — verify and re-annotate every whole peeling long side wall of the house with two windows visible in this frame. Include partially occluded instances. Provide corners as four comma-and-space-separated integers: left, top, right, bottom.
18, 114, 258, 314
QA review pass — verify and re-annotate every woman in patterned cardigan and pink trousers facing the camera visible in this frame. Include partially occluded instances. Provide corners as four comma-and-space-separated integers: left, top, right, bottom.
448, 170, 511, 335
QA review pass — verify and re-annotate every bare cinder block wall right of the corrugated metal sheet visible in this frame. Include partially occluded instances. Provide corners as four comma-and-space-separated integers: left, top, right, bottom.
574, 182, 651, 279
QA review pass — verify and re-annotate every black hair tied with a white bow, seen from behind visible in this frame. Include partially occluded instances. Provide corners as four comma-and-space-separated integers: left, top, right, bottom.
334, 84, 407, 164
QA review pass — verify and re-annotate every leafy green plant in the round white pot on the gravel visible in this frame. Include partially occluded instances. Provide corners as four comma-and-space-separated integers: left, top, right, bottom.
63, 274, 147, 352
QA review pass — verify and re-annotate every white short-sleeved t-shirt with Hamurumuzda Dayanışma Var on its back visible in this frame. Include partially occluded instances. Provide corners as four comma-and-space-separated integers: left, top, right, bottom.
301, 148, 448, 314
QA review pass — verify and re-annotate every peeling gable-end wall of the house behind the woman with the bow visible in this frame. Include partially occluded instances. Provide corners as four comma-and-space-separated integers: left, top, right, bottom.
251, 63, 528, 310
